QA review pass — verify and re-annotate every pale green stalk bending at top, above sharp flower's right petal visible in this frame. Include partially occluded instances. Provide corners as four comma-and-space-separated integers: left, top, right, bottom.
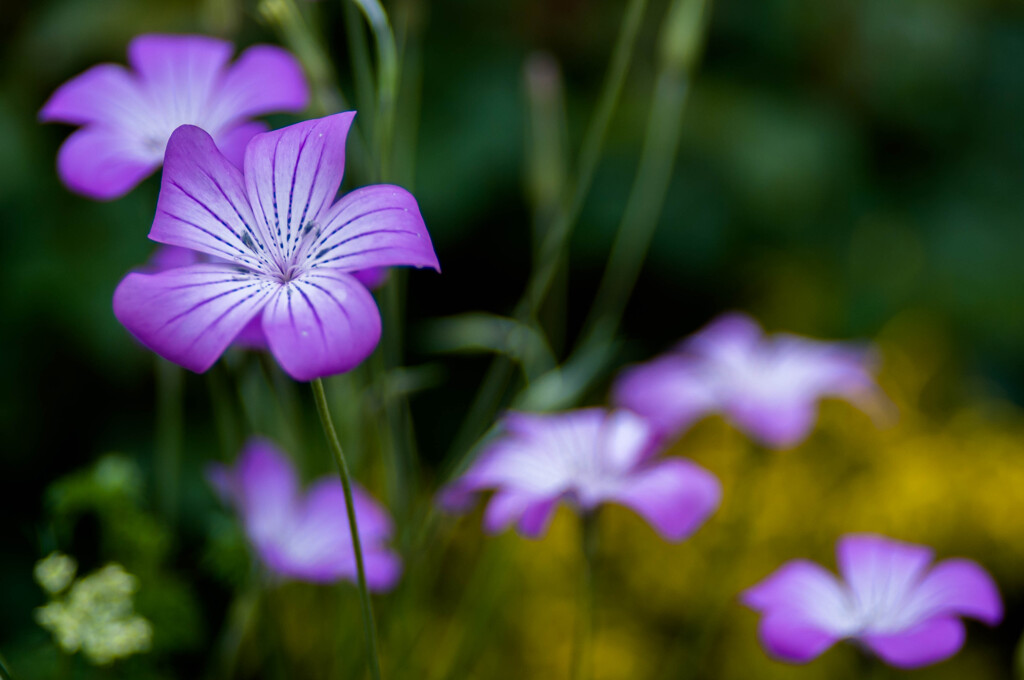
352, 0, 399, 181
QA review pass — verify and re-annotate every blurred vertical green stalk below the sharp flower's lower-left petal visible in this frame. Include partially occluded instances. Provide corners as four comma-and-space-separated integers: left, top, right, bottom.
156, 356, 184, 526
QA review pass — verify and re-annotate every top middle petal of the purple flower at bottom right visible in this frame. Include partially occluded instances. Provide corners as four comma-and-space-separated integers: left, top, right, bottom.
836, 534, 933, 615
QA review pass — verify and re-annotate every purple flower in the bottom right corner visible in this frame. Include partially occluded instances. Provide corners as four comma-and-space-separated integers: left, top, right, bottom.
742, 534, 1002, 668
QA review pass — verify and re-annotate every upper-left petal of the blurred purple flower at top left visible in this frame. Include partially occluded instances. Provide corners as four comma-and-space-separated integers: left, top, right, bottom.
39, 63, 146, 132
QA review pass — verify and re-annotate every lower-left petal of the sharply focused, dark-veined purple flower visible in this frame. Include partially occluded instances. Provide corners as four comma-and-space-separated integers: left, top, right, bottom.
114, 263, 278, 373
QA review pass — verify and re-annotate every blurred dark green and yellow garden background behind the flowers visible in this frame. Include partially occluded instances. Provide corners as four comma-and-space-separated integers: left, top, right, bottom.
0, 0, 1024, 679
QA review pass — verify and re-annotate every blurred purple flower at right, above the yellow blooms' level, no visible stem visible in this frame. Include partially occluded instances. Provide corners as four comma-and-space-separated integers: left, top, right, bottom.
613, 313, 884, 449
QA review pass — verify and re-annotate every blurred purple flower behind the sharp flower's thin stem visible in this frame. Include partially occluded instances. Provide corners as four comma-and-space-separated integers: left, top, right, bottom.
208, 439, 401, 591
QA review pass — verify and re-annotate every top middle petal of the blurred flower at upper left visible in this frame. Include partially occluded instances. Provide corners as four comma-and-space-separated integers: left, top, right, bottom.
128, 34, 234, 115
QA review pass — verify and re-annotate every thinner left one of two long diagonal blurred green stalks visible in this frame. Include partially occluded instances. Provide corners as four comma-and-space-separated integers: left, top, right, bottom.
446, 0, 647, 474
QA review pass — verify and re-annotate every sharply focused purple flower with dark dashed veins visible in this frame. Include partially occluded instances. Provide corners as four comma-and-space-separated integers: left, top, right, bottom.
114, 113, 438, 380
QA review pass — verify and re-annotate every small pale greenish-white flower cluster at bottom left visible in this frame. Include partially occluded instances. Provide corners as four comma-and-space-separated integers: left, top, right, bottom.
35, 553, 153, 666
